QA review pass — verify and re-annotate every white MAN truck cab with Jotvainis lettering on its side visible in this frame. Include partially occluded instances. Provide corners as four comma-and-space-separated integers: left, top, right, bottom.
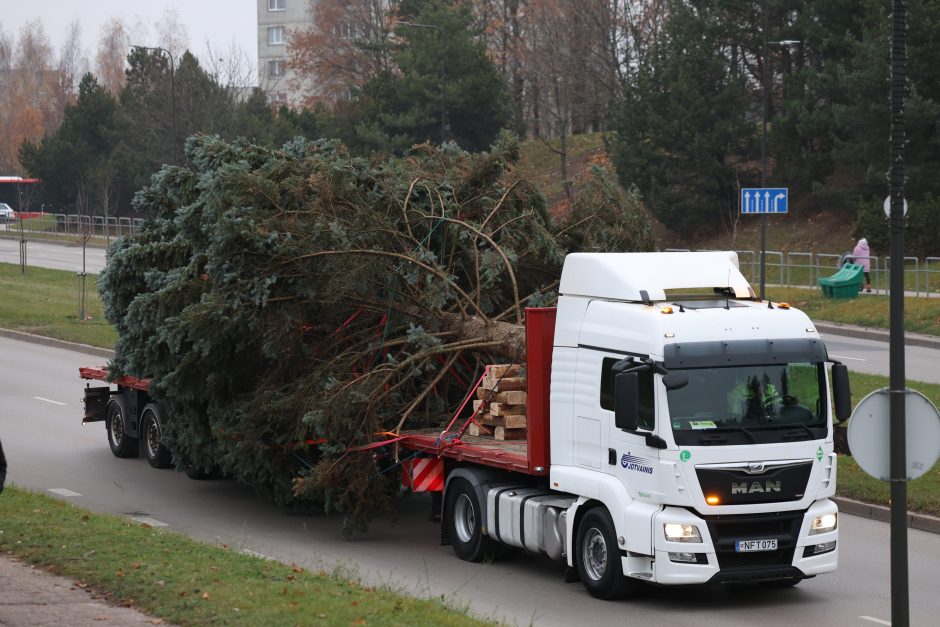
549, 252, 849, 596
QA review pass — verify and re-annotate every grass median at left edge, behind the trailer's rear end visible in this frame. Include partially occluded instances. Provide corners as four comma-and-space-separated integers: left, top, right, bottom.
0, 263, 117, 348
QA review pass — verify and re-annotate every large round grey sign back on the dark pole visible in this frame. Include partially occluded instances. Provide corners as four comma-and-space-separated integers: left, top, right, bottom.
848, 388, 940, 481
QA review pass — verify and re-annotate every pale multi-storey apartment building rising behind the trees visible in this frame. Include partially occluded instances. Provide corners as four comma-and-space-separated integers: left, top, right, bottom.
258, 0, 313, 106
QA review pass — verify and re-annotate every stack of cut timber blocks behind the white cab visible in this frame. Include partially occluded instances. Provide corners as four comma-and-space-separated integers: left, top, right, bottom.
468, 364, 526, 440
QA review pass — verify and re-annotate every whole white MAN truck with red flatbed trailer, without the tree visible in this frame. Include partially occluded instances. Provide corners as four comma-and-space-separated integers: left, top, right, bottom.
81, 252, 851, 599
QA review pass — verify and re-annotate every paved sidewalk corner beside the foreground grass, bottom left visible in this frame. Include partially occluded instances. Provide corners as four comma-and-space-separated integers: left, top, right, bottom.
0, 554, 167, 627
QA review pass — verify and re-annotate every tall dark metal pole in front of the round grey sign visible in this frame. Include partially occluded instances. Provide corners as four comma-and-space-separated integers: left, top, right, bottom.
889, 0, 910, 627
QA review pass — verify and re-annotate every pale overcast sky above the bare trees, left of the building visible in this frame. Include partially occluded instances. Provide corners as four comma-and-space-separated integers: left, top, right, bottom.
0, 0, 258, 79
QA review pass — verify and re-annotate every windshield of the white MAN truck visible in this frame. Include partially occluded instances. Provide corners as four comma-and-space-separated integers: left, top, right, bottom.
667, 363, 827, 444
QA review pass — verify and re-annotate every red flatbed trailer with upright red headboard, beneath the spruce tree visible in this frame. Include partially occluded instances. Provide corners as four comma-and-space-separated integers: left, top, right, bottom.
78, 307, 555, 476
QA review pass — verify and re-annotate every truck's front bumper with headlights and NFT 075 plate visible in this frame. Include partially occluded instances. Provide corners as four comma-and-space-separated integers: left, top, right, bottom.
644, 499, 839, 585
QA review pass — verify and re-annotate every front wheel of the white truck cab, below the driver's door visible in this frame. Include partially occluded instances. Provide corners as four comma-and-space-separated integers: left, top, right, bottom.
574, 507, 639, 599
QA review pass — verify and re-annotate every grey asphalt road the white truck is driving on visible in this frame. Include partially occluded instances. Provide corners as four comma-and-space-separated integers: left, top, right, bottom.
0, 338, 940, 626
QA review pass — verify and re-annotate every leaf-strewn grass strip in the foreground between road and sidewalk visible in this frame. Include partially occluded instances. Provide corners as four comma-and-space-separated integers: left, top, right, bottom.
0, 488, 491, 625
